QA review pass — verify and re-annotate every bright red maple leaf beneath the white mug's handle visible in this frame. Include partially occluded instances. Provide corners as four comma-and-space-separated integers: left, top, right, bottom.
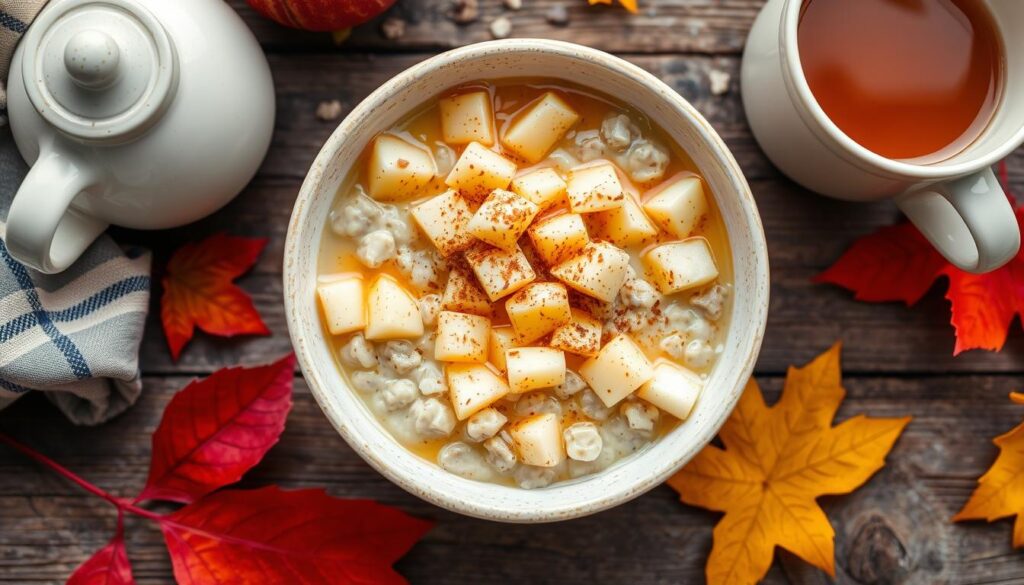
814, 206, 1024, 356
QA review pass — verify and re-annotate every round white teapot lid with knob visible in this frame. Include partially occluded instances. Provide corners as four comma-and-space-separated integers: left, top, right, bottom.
22, 0, 178, 142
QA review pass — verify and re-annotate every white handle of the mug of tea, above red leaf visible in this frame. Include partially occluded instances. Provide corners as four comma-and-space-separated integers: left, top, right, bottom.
896, 168, 1021, 275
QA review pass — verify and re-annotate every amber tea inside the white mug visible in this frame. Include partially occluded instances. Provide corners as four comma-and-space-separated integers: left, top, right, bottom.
798, 0, 1005, 164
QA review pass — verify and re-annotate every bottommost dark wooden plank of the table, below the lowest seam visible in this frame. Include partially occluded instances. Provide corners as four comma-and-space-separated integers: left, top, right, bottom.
0, 376, 1024, 585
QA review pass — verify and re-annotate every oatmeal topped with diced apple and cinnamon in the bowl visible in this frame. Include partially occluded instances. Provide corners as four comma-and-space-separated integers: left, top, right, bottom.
317, 80, 732, 489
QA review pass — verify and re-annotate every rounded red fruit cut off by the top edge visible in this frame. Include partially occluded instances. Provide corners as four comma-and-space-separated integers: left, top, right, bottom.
248, 0, 394, 31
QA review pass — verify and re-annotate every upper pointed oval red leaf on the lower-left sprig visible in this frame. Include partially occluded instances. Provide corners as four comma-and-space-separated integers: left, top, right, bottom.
136, 356, 295, 504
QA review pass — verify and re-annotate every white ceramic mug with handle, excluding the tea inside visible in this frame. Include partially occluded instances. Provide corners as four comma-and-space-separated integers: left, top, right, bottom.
742, 0, 1024, 273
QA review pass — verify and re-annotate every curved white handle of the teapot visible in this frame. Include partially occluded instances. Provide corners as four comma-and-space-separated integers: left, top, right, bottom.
6, 143, 109, 275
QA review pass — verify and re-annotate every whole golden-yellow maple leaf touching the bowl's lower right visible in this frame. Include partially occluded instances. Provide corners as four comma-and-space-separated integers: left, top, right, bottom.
669, 343, 910, 585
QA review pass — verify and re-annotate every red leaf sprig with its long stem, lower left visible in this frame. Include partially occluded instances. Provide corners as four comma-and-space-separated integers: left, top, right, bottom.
0, 356, 431, 585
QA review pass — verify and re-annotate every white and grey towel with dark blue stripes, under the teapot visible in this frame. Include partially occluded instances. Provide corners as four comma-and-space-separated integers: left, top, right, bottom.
0, 128, 150, 425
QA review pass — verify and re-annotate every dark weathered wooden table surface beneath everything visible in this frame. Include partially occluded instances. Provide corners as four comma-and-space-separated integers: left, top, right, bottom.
0, 0, 1024, 585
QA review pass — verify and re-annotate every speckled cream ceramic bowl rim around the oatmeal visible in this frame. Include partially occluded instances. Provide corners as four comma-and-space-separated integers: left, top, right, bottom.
285, 39, 768, 523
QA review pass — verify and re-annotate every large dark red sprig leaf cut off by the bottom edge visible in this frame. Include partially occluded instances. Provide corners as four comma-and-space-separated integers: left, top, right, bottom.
161, 487, 430, 585
